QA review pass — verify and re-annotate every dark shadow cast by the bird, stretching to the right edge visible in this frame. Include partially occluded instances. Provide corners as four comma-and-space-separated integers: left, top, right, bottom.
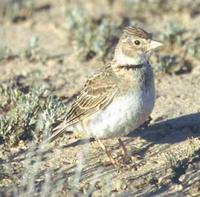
128, 113, 200, 144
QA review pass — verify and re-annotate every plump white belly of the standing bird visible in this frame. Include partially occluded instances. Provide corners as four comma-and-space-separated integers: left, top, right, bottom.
78, 87, 154, 138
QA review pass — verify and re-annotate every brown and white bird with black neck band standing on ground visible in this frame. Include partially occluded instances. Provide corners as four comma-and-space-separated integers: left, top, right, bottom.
47, 26, 162, 165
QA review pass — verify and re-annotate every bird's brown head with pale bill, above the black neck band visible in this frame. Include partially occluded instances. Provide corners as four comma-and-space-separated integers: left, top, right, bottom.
114, 27, 162, 65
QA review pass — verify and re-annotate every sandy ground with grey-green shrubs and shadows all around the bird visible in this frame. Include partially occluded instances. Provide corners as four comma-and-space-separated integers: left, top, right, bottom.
0, 0, 200, 196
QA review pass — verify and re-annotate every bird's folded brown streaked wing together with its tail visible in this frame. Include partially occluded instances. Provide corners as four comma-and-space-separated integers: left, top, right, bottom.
48, 66, 118, 141
